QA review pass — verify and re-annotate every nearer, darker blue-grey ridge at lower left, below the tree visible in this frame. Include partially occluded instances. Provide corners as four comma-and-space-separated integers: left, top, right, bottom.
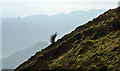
2, 42, 48, 69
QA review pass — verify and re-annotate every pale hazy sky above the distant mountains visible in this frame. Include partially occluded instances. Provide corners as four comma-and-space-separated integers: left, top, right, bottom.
2, 0, 119, 17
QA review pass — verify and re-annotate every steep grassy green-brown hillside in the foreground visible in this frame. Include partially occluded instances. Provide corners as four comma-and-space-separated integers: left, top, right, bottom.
16, 7, 120, 71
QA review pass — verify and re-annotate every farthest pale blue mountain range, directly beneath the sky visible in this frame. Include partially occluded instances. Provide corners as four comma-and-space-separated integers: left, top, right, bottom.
2, 9, 105, 56
